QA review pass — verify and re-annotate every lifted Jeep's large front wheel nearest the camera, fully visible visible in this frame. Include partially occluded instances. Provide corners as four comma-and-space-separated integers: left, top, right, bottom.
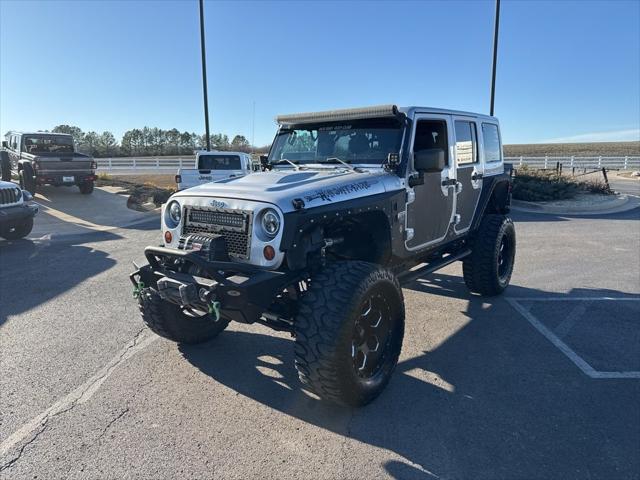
294, 262, 404, 406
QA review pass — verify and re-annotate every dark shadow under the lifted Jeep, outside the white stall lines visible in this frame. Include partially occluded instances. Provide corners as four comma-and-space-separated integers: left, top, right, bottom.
180, 275, 640, 479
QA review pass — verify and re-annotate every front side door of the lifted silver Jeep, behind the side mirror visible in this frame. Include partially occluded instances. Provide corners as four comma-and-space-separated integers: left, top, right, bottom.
405, 115, 456, 250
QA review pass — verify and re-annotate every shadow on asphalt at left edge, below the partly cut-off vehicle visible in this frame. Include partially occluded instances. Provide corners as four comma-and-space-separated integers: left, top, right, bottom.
0, 232, 120, 328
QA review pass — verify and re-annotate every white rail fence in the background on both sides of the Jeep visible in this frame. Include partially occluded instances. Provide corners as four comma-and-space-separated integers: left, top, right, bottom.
96, 156, 640, 175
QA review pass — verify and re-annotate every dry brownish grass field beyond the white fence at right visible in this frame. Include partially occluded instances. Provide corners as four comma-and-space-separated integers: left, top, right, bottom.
504, 142, 640, 157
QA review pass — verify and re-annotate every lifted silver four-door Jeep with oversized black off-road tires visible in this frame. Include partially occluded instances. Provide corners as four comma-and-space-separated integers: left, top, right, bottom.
131, 105, 516, 405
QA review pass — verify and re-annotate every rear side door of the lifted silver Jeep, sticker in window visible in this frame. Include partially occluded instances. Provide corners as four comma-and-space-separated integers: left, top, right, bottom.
453, 117, 484, 234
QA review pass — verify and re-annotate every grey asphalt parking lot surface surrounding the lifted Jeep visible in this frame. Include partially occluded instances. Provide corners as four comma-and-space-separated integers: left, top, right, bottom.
0, 186, 640, 479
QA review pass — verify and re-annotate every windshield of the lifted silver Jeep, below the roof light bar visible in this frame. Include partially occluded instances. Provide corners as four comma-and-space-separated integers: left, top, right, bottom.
269, 119, 402, 165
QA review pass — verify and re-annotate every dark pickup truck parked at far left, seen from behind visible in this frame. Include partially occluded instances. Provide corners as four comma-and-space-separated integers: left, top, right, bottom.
0, 132, 97, 195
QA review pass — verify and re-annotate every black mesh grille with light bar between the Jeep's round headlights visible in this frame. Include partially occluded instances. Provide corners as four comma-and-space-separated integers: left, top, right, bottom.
182, 207, 253, 260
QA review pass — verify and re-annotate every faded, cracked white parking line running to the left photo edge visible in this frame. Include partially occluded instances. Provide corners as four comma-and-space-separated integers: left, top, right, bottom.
0, 329, 160, 458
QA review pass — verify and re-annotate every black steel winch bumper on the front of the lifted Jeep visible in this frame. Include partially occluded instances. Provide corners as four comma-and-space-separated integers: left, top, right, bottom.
129, 247, 299, 323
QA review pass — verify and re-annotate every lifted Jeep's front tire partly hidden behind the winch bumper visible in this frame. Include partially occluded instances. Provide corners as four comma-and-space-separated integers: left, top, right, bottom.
138, 288, 229, 343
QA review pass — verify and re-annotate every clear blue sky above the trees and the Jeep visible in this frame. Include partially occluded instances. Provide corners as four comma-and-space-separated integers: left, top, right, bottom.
0, 0, 640, 145
